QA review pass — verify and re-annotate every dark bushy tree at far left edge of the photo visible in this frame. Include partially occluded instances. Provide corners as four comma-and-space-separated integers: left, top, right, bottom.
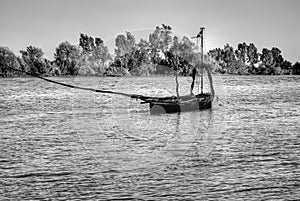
0, 47, 19, 77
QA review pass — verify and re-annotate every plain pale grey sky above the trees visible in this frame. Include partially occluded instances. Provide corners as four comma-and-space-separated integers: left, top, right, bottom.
0, 0, 300, 63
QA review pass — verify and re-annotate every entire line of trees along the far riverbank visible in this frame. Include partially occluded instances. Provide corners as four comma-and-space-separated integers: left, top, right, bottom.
0, 24, 300, 77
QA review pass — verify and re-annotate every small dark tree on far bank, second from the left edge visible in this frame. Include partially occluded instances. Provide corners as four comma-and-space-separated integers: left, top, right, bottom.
20, 46, 47, 75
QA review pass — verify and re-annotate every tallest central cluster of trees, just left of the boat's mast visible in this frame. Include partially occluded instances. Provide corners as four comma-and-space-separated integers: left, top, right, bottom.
108, 24, 198, 75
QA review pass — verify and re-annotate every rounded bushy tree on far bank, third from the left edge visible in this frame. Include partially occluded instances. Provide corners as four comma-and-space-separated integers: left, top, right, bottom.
54, 41, 80, 75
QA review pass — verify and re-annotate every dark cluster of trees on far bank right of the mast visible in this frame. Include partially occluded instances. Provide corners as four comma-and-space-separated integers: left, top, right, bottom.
208, 42, 292, 75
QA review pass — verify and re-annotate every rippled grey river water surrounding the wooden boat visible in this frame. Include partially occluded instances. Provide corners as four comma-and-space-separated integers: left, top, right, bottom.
0, 76, 300, 200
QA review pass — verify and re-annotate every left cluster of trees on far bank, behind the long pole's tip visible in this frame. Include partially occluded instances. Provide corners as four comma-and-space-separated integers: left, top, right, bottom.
0, 34, 111, 77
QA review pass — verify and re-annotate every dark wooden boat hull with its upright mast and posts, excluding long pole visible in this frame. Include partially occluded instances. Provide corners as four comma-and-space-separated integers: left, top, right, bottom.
131, 28, 214, 114
